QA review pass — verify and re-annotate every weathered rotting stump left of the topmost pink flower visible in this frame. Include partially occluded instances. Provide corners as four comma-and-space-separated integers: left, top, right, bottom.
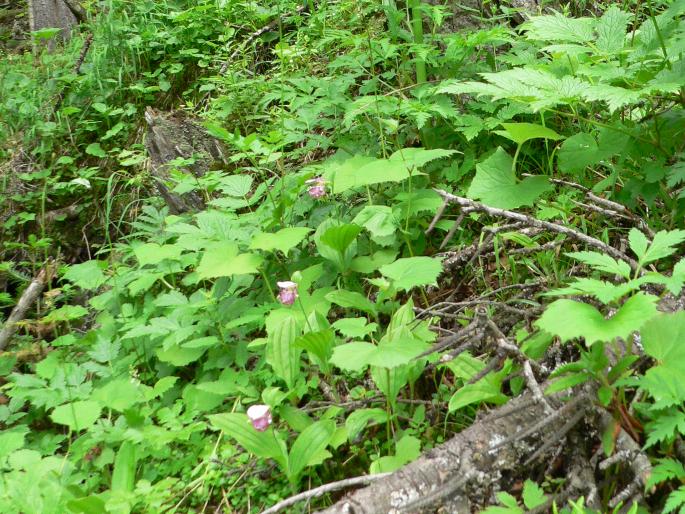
145, 107, 224, 214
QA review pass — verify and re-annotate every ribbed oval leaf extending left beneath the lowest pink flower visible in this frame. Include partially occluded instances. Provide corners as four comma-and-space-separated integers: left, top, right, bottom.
207, 412, 288, 470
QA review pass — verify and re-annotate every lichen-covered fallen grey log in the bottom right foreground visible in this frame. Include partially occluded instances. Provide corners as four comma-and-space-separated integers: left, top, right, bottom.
319, 385, 649, 514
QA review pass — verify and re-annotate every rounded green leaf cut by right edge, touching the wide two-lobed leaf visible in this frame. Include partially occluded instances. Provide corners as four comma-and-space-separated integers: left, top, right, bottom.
640, 311, 685, 367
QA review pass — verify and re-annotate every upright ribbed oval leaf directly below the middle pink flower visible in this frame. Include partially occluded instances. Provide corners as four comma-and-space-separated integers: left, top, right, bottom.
266, 316, 302, 389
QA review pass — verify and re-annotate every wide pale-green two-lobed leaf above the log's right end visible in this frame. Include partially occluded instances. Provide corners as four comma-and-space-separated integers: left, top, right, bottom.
536, 293, 657, 345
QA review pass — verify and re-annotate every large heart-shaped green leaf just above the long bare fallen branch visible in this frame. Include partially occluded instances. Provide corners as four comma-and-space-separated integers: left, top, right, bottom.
468, 148, 552, 209
